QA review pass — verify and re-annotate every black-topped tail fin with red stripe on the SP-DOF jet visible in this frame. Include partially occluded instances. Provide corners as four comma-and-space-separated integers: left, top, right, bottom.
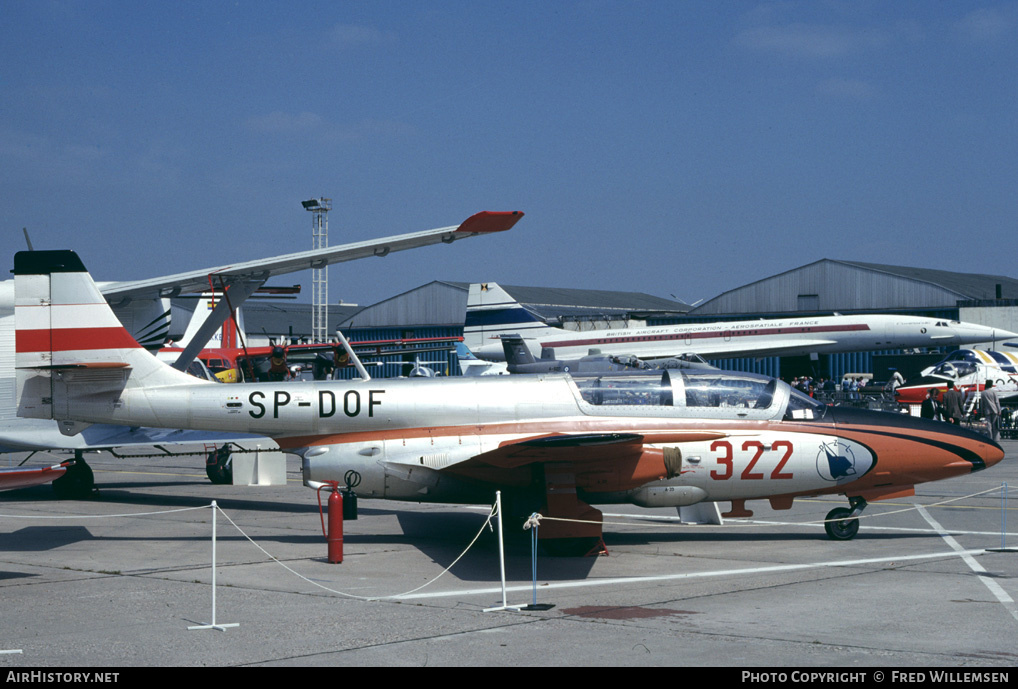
14, 250, 194, 435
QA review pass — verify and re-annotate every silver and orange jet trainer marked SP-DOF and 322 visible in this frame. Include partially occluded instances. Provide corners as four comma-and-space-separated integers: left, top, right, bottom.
14, 251, 1004, 550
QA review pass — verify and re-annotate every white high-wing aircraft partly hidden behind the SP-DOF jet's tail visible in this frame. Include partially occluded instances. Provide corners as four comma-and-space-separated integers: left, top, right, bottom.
0, 211, 523, 493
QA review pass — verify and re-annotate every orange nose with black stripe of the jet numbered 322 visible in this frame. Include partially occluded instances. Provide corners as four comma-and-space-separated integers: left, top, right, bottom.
831, 407, 1004, 482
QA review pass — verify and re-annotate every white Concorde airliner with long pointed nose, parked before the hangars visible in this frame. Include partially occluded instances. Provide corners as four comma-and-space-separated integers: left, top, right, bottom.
463, 282, 1018, 361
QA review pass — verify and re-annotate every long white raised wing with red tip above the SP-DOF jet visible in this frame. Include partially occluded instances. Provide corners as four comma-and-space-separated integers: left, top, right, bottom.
99, 211, 523, 303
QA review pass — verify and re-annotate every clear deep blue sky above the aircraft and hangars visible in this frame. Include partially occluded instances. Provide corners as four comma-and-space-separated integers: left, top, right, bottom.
0, 0, 1018, 304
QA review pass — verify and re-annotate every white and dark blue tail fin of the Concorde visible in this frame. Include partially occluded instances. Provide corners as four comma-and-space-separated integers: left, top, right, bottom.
463, 282, 560, 358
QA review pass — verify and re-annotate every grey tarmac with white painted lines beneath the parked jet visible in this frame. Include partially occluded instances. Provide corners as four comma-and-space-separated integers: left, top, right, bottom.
0, 441, 1018, 667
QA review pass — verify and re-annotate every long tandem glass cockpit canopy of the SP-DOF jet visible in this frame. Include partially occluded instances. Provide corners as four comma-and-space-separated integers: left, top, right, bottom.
572, 369, 827, 420
